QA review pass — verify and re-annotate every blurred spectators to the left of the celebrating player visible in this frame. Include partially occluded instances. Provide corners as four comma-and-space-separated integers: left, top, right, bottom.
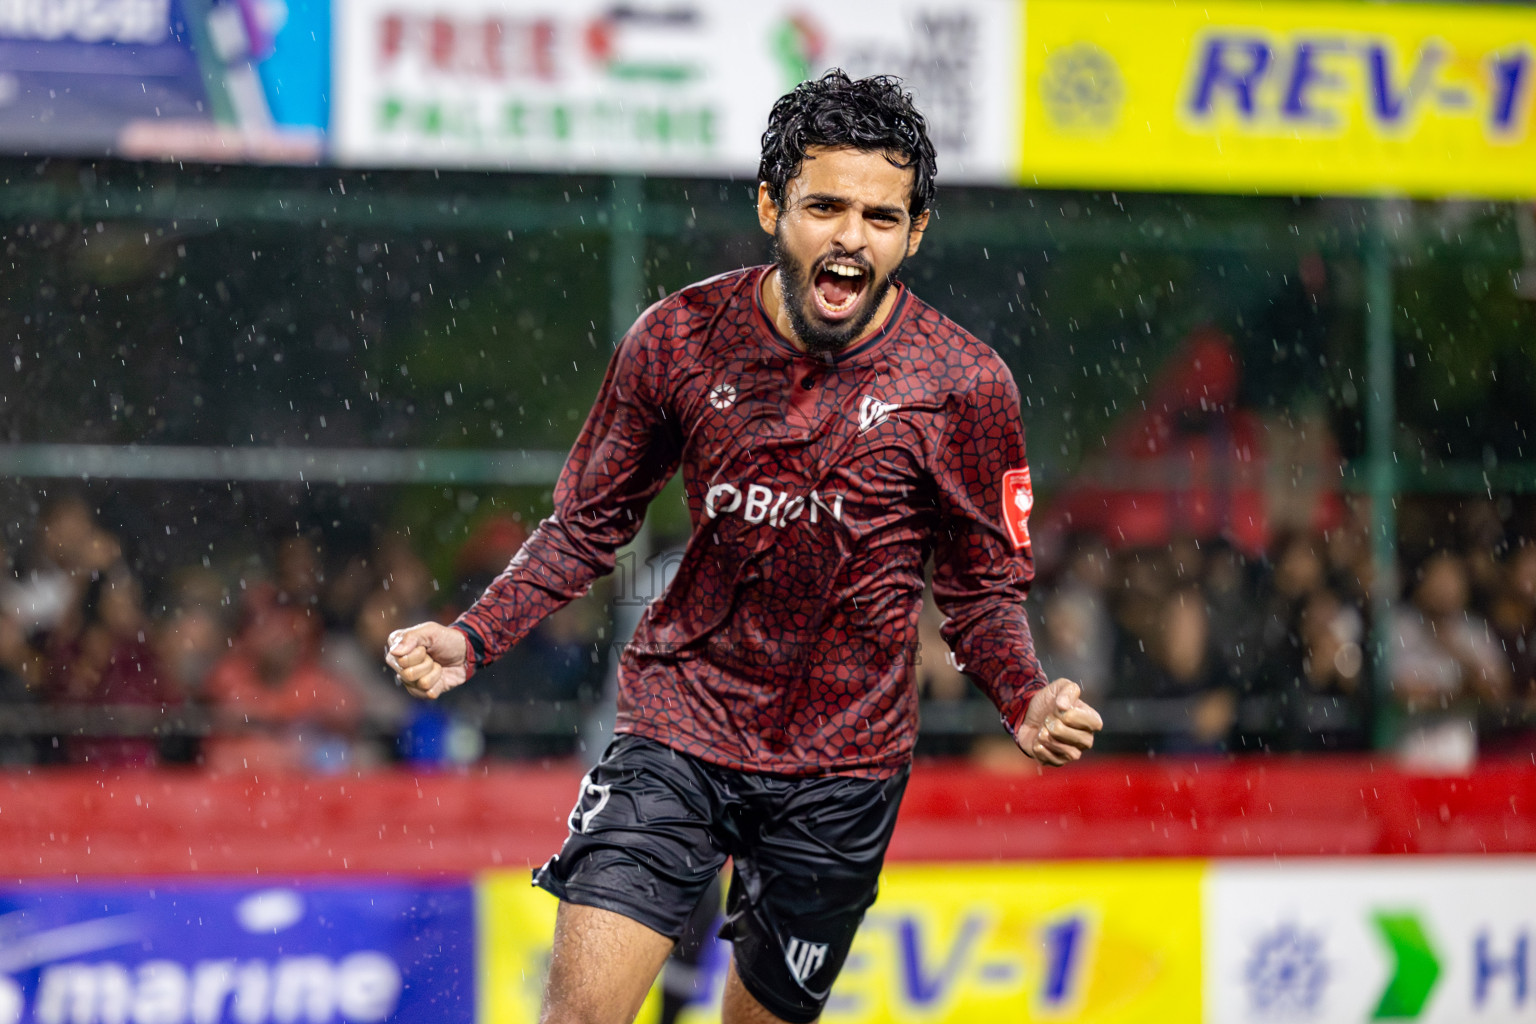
0, 494, 602, 772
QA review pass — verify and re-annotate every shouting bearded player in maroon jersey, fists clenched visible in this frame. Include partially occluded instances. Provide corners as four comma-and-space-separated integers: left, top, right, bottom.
387, 71, 1103, 1024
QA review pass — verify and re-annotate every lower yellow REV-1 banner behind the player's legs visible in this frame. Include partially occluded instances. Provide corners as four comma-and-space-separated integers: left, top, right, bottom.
479, 861, 1206, 1024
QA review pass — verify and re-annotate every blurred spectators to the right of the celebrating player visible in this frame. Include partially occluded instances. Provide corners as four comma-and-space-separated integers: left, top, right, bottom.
958, 500, 1536, 771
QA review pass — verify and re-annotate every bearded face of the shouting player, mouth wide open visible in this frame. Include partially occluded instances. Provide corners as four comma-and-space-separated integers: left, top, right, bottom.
757, 146, 928, 353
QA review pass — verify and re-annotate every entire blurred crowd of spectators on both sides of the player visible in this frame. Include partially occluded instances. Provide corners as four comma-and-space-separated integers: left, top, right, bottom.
0, 494, 1536, 772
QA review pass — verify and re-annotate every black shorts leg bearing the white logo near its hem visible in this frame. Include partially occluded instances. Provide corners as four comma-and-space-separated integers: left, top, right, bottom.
722, 772, 906, 1021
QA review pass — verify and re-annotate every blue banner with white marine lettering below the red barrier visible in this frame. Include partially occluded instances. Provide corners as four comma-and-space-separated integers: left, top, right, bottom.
0, 881, 475, 1024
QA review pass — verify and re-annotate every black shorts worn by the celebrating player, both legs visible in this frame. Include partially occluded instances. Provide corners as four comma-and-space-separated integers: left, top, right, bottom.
533, 735, 906, 1021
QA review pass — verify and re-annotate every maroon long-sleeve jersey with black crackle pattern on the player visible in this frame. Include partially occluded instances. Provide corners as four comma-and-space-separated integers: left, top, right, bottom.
455, 267, 1044, 777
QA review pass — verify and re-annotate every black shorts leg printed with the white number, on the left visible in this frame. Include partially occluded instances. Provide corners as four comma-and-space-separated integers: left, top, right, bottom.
533, 735, 725, 940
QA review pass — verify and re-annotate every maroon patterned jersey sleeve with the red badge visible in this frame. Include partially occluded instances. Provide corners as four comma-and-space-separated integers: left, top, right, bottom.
934, 362, 1046, 731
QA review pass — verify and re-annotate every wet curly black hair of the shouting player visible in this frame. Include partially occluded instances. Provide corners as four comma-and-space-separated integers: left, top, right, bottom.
757, 68, 938, 216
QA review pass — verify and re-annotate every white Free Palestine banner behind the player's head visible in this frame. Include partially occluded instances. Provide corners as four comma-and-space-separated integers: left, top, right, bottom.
332, 0, 1021, 183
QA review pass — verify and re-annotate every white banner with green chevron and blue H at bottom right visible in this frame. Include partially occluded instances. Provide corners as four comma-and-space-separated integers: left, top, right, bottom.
1203, 857, 1536, 1024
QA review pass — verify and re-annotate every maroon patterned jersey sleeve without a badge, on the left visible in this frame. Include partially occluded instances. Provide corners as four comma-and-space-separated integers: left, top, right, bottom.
453, 307, 682, 674
